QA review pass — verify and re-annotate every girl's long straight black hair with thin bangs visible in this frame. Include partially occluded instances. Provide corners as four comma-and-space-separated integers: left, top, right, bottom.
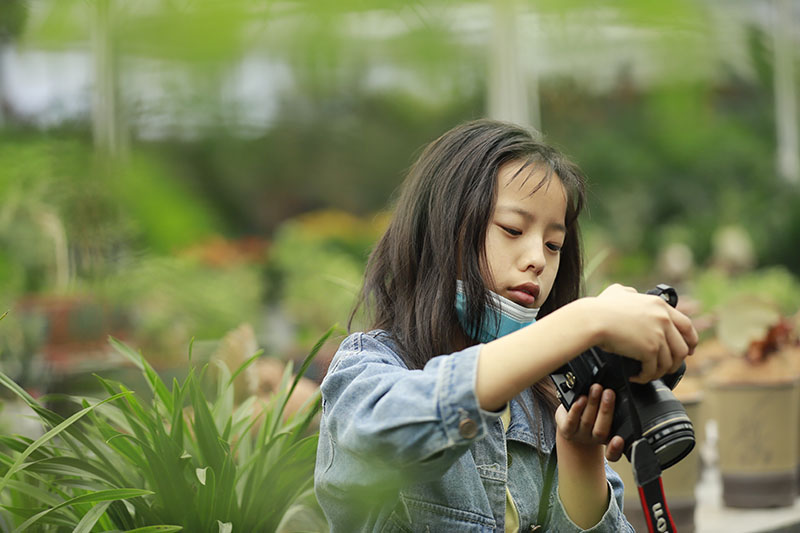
350, 119, 585, 408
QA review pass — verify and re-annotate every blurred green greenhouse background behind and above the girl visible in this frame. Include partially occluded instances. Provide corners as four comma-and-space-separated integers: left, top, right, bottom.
0, 0, 800, 391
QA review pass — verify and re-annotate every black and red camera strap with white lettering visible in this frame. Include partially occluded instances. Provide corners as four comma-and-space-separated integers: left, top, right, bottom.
631, 438, 677, 533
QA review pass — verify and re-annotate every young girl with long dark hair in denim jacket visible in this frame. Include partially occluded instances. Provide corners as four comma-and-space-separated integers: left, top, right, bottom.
315, 120, 697, 533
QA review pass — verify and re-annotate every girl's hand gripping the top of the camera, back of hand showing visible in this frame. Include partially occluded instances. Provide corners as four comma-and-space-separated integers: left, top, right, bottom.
596, 284, 697, 383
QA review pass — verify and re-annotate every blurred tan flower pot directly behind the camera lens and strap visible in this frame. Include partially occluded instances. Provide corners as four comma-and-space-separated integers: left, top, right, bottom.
612, 378, 705, 533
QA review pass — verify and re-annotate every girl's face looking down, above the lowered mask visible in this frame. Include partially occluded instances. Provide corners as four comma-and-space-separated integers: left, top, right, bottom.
486, 161, 567, 307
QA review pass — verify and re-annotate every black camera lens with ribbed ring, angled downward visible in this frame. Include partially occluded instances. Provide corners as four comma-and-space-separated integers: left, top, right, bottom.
615, 380, 695, 469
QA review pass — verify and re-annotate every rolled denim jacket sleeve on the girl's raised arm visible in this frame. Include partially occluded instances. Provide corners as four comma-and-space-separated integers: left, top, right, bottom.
320, 333, 500, 484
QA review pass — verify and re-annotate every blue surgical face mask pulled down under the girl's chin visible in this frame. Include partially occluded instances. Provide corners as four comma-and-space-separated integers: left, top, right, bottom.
456, 280, 539, 342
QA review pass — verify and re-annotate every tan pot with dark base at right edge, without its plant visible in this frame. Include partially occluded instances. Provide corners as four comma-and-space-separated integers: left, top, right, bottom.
709, 355, 800, 508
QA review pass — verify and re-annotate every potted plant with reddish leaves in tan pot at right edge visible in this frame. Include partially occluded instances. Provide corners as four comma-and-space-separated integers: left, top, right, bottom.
708, 307, 800, 507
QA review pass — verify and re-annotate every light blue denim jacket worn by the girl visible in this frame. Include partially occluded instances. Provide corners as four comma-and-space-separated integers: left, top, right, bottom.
314, 330, 633, 533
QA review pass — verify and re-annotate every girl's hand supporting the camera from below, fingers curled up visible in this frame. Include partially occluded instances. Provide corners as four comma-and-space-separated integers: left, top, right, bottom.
556, 383, 625, 461
